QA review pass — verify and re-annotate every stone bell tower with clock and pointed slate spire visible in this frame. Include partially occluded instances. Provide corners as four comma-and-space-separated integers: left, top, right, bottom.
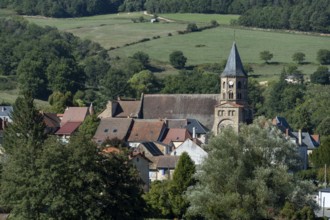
213, 42, 253, 135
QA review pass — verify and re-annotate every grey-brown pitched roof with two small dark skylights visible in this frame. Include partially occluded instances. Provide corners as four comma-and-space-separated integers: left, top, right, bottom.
94, 118, 133, 144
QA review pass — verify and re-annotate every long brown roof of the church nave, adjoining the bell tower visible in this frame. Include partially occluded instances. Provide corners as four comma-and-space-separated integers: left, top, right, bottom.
143, 94, 220, 130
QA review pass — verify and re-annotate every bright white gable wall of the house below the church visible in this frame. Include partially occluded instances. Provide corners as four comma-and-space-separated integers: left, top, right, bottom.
171, 139, 207, 165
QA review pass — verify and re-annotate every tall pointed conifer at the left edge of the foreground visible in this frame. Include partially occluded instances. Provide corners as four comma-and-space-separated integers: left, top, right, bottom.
0, 94, 46, 219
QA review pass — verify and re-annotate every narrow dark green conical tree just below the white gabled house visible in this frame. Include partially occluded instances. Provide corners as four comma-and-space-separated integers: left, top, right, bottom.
170, 152, 195, 219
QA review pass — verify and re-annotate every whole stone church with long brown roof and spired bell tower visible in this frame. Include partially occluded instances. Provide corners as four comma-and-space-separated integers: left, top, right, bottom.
99, 42, 253, 144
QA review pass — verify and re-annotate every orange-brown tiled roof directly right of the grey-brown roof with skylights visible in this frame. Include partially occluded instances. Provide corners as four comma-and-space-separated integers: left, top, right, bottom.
128, 119, 165, 142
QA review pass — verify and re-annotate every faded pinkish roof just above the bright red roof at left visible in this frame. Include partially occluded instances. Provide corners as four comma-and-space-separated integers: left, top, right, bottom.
61, 107, 89, 125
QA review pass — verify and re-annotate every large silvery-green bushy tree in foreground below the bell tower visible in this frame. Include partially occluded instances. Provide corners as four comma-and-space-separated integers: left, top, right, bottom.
187, 118, 314, 219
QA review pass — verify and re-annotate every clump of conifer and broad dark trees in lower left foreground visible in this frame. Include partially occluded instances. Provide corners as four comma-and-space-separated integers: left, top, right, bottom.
0, 96, 144, 219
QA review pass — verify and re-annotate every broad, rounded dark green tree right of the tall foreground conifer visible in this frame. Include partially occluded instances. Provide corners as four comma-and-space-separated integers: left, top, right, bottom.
38, 131, 144, 219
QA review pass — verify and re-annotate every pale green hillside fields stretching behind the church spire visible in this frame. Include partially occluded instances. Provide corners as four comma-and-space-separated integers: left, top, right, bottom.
2, 9, 330, 81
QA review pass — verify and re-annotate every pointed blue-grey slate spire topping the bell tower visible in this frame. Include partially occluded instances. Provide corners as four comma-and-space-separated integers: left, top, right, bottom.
221, 42, 247, 77
